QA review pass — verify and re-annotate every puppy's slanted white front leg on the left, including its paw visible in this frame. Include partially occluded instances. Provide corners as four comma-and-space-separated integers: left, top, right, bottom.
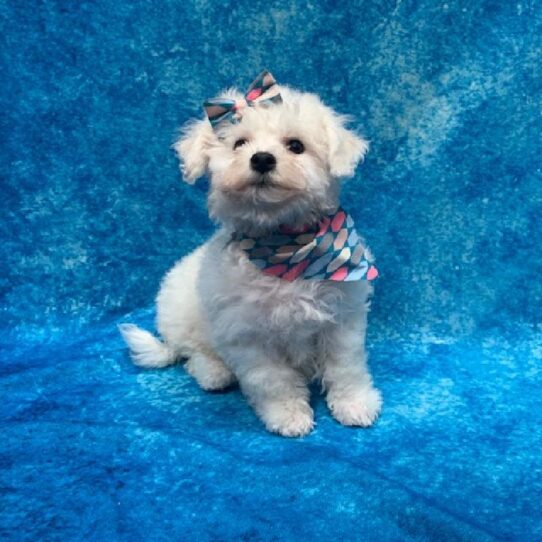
221, 341, 314, 437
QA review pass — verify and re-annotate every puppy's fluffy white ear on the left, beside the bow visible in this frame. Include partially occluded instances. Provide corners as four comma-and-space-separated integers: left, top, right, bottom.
173, 119, 216, 184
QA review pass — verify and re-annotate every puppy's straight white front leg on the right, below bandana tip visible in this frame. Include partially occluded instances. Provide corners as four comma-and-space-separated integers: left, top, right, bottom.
320, 318, 382, 427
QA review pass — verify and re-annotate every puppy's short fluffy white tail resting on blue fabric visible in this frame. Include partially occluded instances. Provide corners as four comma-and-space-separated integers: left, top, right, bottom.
118, 324, 179, 369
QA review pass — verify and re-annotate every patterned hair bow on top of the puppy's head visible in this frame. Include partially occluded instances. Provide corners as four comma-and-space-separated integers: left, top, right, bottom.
203, 70, 282, 128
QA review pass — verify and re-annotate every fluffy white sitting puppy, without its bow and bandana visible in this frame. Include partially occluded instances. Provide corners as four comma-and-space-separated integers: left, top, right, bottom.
121, 79, 381, 436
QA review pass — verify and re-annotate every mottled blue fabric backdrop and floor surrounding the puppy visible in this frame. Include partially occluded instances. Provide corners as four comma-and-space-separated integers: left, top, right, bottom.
0, 0, 542, 541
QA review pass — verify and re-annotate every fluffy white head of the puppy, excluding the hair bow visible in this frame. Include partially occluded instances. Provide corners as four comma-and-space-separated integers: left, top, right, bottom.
174, 87, 368, 230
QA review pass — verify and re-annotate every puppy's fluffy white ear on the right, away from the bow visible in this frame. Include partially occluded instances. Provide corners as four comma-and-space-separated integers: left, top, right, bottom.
324, 110, 369, 177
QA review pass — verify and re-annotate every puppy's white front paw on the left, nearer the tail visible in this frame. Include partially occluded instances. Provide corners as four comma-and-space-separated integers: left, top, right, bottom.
258, 400, 314, 437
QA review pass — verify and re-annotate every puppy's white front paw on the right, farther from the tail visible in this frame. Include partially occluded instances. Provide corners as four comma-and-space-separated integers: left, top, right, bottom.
327, 388, 382, 427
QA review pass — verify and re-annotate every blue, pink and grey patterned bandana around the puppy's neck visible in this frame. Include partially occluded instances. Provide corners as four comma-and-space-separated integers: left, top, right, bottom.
232, 208, 378, 281
